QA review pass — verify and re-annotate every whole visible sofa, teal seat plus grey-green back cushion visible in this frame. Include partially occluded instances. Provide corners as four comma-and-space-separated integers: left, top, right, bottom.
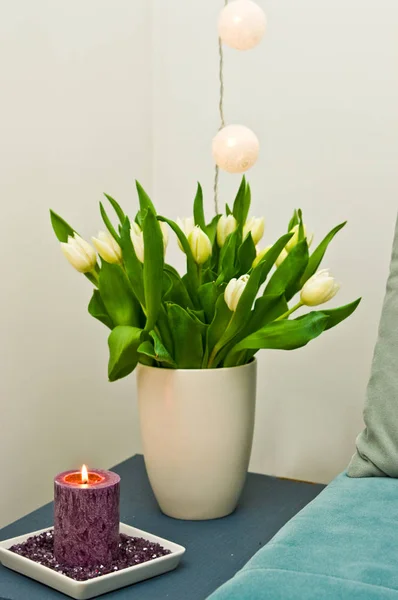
210, 221, 398, 600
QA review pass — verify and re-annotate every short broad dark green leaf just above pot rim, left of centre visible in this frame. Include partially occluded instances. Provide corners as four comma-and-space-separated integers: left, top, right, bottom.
167, 304, 203, 369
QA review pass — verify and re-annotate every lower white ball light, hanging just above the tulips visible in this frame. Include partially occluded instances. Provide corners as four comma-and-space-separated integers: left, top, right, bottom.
213, 125, 260, 173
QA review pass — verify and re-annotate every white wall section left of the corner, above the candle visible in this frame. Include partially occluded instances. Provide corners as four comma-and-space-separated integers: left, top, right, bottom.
0, 0, 152, 525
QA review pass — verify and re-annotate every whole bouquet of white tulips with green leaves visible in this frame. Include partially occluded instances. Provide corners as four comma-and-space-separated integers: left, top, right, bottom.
51, 178, 360, 381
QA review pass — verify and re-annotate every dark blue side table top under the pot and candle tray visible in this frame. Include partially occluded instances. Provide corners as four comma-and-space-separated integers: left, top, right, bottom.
0, 455, 325, 600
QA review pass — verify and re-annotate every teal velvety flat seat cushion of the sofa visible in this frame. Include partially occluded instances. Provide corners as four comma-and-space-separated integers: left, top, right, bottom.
207, 474, 398, 600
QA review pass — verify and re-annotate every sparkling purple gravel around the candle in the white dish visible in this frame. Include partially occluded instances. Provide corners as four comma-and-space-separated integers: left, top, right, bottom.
10, 530, 171, 581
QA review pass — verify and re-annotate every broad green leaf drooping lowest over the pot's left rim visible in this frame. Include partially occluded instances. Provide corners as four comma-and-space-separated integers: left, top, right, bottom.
108, 325, 143, 381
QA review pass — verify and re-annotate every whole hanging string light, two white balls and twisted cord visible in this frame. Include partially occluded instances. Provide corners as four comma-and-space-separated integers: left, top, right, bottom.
212, 0, 267, 213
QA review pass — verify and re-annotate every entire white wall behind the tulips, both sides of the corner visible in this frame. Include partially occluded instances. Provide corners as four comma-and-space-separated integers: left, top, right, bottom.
0, 0, 398, 525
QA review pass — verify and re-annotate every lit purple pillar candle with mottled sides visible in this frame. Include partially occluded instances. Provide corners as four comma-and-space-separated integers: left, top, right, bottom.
54, 467, 120, 567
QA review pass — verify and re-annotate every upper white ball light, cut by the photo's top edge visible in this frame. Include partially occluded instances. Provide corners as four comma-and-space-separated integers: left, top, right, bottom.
218, 0, 267, 50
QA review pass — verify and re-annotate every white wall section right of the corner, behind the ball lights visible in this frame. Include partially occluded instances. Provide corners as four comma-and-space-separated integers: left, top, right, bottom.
153, 0, 398, 482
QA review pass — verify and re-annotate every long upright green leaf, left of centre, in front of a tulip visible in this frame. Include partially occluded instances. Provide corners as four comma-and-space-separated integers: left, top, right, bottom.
142, 210, 164, 331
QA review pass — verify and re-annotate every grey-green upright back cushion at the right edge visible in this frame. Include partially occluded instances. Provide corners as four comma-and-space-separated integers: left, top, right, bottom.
348, 216, 398, 477
